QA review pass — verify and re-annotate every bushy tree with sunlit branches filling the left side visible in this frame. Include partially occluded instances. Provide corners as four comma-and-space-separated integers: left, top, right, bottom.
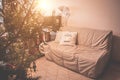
0, 0, 44, 77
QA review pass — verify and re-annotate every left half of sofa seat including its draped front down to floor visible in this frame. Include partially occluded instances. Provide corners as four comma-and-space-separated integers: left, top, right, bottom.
44, 41, 78, 72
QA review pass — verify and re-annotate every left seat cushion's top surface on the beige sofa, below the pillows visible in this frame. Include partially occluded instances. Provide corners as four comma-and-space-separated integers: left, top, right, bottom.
48, 41, 77, 61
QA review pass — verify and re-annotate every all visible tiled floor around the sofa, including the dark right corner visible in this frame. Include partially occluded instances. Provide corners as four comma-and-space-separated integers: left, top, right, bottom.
30, 57, 120, 80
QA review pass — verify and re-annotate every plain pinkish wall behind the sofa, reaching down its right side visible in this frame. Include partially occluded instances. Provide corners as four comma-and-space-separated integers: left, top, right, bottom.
48, 0, 120, 62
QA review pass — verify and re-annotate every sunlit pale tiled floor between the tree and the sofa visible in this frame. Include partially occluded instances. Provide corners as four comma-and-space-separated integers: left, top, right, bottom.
27, 57, 93, 80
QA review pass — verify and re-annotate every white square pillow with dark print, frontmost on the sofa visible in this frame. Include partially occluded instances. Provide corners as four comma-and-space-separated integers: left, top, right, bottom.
60, 32, 77, 45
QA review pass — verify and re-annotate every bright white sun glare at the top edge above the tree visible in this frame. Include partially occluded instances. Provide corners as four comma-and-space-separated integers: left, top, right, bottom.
37, 0, 53, 16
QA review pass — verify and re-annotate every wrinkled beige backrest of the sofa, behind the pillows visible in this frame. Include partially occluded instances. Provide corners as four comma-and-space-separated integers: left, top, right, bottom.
61, 27, 112, 49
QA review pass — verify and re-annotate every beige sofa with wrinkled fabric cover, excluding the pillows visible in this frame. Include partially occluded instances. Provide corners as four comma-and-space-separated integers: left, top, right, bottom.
43, 27, 112, 78
